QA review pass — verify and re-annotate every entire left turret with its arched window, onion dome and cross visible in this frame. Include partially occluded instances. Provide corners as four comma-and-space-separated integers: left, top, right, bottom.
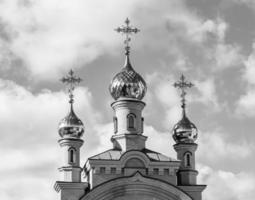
54, 70, 87, 200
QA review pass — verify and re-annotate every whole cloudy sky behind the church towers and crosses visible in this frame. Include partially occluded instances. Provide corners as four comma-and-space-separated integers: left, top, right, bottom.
0, 0, 255, 200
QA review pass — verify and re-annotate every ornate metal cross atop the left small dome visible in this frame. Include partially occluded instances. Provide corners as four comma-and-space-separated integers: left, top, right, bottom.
60, 69, 82, 105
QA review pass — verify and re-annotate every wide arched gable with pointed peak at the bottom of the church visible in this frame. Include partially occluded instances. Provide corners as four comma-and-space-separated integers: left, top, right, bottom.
81, 172, 192, 200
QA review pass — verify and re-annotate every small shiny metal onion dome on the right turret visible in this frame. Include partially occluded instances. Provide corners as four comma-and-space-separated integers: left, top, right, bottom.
173, 114, 198, 143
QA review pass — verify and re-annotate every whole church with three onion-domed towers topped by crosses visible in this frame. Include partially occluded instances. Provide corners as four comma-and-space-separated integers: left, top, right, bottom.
54, 19, 206, 200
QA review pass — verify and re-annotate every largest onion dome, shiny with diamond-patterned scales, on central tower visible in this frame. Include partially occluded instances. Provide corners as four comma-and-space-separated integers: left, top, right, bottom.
109, 54, 147, 100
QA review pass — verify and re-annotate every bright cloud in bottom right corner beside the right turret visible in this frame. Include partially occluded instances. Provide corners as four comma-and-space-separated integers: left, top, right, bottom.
198, 165, 255, 200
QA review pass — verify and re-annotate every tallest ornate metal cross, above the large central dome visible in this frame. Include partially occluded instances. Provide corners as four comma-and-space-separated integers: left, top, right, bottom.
115, 18, 140, 55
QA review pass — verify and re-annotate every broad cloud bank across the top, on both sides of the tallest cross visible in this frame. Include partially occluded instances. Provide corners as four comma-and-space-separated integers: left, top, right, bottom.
0, 0, 241, 80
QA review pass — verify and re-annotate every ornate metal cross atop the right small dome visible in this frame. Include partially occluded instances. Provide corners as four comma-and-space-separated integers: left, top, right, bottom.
174, 74, 194, 115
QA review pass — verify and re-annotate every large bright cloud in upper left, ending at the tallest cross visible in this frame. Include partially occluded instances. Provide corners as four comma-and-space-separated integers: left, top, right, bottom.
0, 0, 155, 79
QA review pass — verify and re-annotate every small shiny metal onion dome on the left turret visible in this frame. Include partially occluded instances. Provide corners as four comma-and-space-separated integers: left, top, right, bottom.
58, 104, 84, 138
